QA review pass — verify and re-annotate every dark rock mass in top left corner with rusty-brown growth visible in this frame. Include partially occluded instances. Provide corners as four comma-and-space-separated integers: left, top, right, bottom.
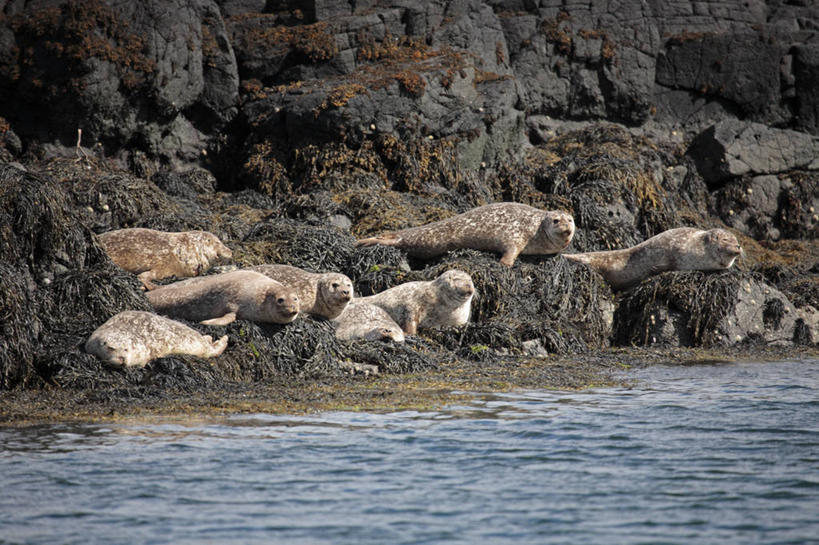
0, 0, 238, 165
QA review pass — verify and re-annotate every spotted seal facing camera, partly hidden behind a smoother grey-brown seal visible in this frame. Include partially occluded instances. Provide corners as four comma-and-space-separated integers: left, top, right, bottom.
247, 265, 353, 320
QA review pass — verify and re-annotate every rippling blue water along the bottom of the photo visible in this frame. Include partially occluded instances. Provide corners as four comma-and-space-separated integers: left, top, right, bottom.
0, 361, 819, 545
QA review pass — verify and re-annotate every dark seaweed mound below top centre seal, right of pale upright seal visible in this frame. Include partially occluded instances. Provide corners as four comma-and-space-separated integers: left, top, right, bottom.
401, 250, 613, 357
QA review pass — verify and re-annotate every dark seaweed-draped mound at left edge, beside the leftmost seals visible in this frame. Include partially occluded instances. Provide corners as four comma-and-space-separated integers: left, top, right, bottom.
0, 164, 147, 388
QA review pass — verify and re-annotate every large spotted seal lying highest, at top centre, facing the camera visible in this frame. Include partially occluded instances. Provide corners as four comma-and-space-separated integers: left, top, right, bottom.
356, 202, 575, 267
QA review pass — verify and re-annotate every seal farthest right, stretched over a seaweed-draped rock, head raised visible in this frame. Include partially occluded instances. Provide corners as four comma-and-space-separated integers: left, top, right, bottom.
564, 227, 742, 290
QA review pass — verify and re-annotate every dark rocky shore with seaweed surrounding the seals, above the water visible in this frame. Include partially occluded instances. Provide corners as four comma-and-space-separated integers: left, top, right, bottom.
0, 0, 819, 422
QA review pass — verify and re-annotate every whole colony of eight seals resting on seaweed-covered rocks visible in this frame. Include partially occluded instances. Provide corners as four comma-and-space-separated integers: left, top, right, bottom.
85, 209, 742, 366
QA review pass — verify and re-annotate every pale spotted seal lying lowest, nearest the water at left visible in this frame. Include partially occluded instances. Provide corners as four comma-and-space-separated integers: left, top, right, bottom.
85, 310, 228, 367
